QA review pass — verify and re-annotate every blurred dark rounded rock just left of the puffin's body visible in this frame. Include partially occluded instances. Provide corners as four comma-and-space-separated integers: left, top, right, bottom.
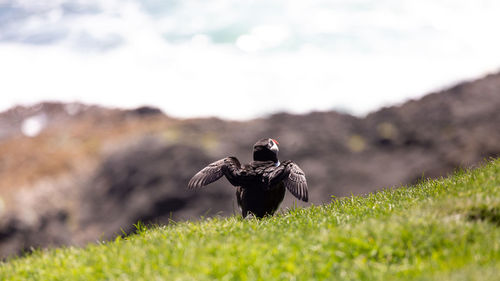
79, 138, 232, 238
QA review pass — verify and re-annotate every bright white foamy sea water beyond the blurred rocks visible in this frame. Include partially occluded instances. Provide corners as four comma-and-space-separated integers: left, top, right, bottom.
0, 0, 500, 119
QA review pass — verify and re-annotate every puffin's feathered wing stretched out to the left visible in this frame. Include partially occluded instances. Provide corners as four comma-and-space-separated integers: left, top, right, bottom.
188, 157, 241, 189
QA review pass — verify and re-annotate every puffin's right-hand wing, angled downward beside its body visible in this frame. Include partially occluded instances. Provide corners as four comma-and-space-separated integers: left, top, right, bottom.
281, 160, 309, 202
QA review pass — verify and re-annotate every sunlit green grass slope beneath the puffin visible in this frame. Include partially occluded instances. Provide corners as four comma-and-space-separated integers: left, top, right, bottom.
0, 160, 500, 280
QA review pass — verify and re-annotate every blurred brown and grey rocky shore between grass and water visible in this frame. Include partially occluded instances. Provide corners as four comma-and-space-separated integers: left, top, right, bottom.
0, 74, 500, 257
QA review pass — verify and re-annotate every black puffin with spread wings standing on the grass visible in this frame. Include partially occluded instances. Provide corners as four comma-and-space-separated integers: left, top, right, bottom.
188, 138, 308, 218
